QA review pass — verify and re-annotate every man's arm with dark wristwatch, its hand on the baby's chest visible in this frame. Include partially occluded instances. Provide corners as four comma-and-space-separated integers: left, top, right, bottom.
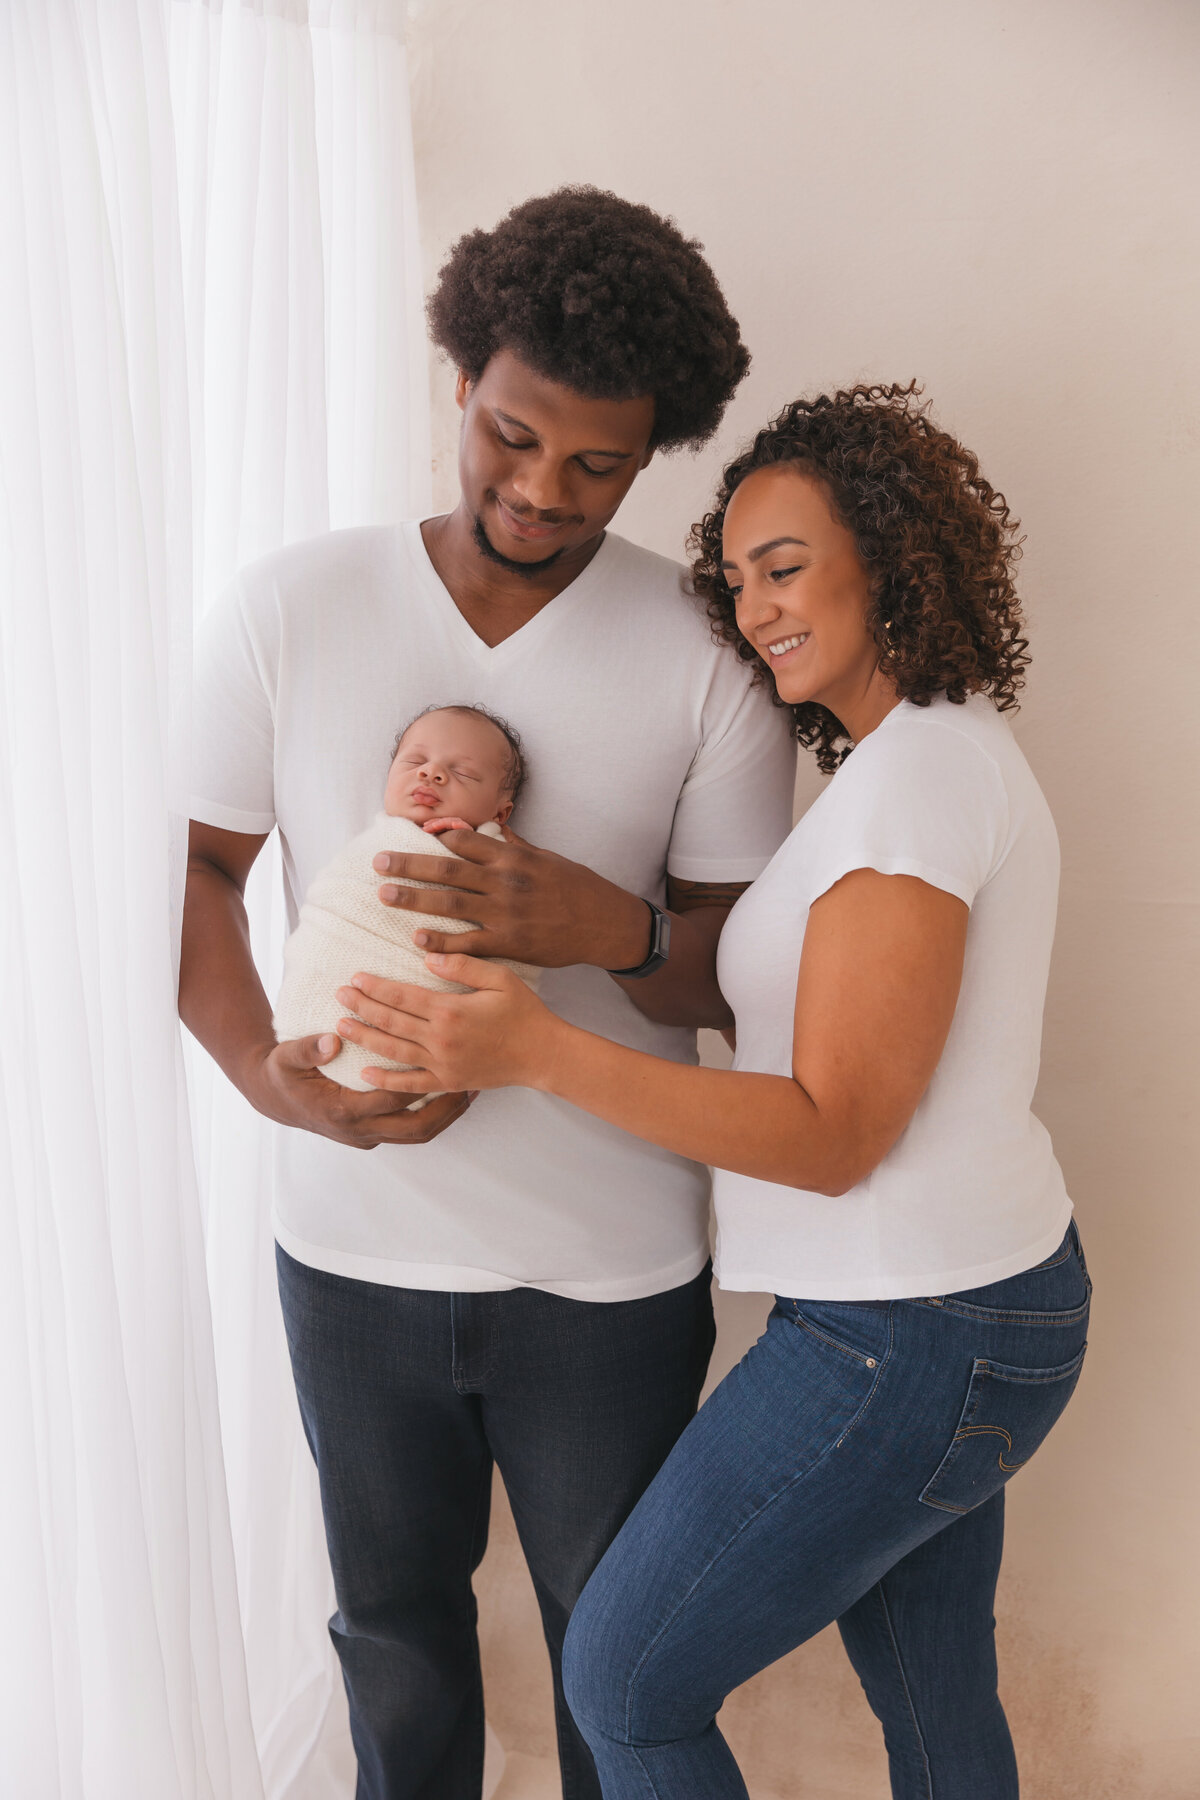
374, 830, 745, 1030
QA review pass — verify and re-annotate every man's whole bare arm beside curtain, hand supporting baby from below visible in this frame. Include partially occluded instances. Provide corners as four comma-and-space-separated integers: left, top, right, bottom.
180, 821, 470, 1150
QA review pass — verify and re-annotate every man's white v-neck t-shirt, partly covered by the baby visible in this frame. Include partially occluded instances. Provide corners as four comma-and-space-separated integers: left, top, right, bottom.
191, 522, 795, 1301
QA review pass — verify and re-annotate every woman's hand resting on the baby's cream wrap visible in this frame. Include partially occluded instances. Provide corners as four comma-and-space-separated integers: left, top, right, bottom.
338, 952, 561, 1094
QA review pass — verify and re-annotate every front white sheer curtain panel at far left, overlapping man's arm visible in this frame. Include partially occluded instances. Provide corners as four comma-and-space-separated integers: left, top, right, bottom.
0, 0, 261, 1800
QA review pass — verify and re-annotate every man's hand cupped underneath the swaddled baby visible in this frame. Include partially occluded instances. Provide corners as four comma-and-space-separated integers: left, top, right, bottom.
241, 1031, 475, 1150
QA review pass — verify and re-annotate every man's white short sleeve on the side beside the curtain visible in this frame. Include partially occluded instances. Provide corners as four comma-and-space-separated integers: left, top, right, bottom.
191, 581, 277, 835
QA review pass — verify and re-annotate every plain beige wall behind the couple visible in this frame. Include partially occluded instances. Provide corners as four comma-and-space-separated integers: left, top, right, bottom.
412, 0, 1200, 1800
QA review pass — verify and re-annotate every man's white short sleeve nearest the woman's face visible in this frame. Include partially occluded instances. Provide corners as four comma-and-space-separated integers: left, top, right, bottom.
667, 655, 795, 882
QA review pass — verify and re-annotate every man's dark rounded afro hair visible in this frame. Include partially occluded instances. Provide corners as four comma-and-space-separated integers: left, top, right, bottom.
428, 187, 750, 450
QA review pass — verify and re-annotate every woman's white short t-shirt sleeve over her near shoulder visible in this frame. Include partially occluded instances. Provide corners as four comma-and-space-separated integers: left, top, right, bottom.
804, 711, 1009, 907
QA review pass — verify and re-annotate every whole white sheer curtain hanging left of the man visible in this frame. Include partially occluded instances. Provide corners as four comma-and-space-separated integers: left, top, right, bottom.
0, 0, 437, 1800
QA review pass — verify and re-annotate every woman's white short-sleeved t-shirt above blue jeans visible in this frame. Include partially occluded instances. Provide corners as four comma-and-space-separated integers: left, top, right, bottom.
714, 695, 1070, 1300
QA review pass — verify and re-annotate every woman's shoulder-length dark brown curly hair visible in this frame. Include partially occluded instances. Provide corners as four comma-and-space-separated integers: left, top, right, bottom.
689, 382, 1029, 774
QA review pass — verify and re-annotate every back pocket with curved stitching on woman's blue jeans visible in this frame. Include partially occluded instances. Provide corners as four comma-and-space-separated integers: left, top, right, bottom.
919, 1345, 1087, 1512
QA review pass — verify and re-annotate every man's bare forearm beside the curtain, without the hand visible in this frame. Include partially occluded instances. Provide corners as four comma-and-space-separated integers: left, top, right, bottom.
180, 857, 275, 1094
